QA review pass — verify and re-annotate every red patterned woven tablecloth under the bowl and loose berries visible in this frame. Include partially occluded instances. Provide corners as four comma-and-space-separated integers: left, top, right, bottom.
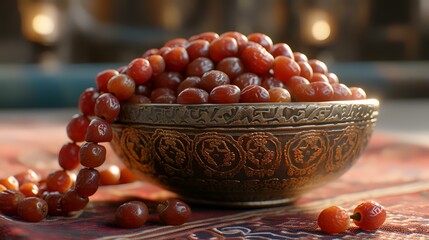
0, 111, 429, 240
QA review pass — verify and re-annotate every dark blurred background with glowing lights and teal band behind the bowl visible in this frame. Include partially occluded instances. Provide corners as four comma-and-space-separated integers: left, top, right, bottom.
0, 0, 429, 109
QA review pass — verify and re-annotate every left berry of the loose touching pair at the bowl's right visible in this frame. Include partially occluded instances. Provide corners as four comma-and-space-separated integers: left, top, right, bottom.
317, 206, 350, 234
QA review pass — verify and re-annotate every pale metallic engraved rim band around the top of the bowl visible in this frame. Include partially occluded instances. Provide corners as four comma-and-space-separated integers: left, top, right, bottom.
114, 99, 379, 127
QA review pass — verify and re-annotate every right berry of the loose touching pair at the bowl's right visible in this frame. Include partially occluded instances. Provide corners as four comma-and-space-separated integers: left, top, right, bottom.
350, 201, 386, 231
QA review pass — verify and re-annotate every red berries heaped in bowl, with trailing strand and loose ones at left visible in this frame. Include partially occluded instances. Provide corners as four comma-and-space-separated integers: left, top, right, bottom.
0, 32, 380, 232
